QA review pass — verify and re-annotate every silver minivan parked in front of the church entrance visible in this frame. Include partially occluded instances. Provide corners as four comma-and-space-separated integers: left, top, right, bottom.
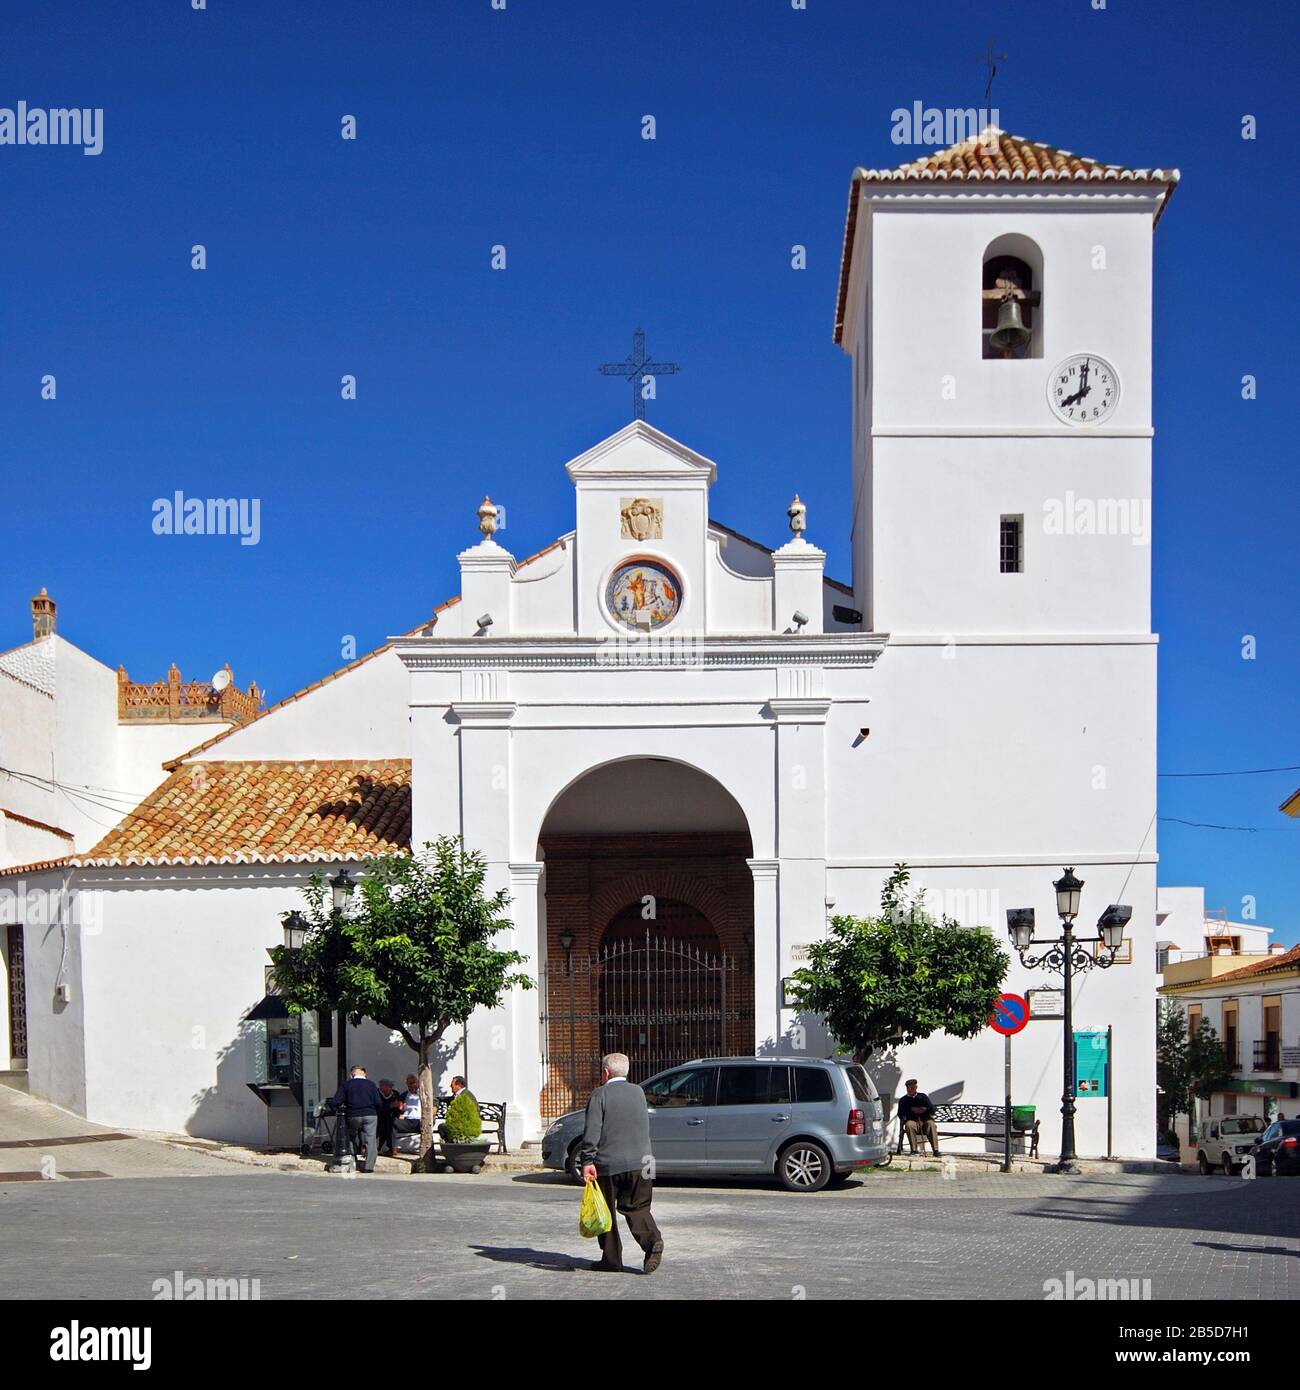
542, 1056, 890, 1193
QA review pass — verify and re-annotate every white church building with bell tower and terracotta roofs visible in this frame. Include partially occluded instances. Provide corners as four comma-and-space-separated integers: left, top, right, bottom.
0, 131, 1178, 1156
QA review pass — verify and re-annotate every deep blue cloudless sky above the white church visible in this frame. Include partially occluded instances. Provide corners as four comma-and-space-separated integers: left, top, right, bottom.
0, 0, 1300, 942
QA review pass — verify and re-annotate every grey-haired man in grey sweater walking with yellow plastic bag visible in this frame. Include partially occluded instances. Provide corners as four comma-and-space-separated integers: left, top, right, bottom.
580, 1052, 663, 1275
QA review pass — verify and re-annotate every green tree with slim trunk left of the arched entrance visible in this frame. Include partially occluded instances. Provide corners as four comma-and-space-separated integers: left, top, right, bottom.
271, 835, 534, 1168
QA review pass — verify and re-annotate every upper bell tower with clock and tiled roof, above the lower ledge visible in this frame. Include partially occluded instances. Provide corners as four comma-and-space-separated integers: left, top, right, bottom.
836, 126, 1178, 637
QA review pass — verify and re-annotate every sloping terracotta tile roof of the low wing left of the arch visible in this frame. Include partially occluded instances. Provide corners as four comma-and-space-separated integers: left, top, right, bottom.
75, 758, 410, 866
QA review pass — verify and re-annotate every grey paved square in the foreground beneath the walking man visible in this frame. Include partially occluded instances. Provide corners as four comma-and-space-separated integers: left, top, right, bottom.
0, 1165, 1300, 1300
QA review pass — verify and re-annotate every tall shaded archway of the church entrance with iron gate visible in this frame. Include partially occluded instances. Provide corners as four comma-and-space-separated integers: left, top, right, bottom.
538, 759, 754, 1118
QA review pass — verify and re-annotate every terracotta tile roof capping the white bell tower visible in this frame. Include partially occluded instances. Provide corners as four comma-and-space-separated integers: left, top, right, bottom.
836, 125, 1179, 342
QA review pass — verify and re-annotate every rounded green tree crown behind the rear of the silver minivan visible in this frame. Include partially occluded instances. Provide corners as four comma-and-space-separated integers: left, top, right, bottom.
793, 865, 1009, 1062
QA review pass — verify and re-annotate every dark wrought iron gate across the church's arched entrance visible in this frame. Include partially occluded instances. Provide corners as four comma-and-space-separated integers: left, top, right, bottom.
542, 931, 741, 1119
